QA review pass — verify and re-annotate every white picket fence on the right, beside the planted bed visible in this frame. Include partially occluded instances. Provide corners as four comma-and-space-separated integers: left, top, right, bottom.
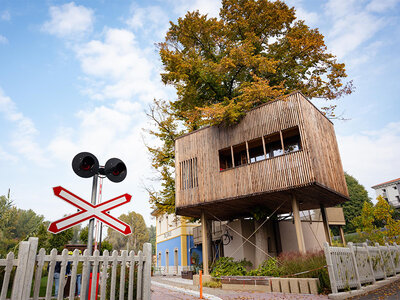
324, 243, 400, 293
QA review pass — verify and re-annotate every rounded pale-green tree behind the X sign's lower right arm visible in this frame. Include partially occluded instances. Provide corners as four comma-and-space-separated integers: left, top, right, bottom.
107, 211, 149, 253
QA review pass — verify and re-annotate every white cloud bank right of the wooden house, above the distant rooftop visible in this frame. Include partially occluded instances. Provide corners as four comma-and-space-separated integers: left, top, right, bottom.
338, 122, 400, 199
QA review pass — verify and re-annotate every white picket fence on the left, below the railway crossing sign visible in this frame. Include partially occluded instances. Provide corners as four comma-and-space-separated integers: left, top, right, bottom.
0, 238, 152, 300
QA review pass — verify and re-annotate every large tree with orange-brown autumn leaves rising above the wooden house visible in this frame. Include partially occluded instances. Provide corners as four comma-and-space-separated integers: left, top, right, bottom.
149, 0, 353, 212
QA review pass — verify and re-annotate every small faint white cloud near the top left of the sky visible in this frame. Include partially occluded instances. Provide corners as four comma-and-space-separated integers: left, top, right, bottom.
42, 2, 94, 38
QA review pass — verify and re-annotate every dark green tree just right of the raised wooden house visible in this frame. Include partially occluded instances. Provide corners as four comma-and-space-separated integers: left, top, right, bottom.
339, 173, 372, 233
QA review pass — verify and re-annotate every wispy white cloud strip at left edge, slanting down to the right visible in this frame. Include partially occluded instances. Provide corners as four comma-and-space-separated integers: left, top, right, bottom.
0, 89, 49, 165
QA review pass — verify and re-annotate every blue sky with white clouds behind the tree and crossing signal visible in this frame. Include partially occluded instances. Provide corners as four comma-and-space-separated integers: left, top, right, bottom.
0, 0, 400, 225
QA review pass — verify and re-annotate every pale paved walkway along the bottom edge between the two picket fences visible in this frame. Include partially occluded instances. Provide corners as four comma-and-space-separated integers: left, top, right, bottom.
151, 276, 328, 300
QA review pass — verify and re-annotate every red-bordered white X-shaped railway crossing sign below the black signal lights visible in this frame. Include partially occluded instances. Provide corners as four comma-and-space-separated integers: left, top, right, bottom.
47, 186, 132, 235
